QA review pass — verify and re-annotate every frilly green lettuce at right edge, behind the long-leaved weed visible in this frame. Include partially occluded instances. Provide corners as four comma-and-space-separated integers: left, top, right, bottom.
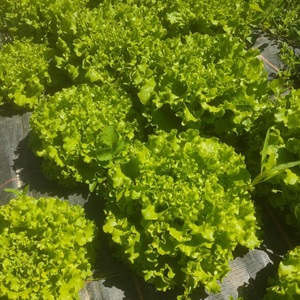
253, 89, 300, 228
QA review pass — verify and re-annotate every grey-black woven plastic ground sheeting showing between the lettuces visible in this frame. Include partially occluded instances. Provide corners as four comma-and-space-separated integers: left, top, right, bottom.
0, 37, 296, 300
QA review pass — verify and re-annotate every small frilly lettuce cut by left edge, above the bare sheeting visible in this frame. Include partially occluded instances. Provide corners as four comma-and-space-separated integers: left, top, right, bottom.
0, 40, 51, 108
